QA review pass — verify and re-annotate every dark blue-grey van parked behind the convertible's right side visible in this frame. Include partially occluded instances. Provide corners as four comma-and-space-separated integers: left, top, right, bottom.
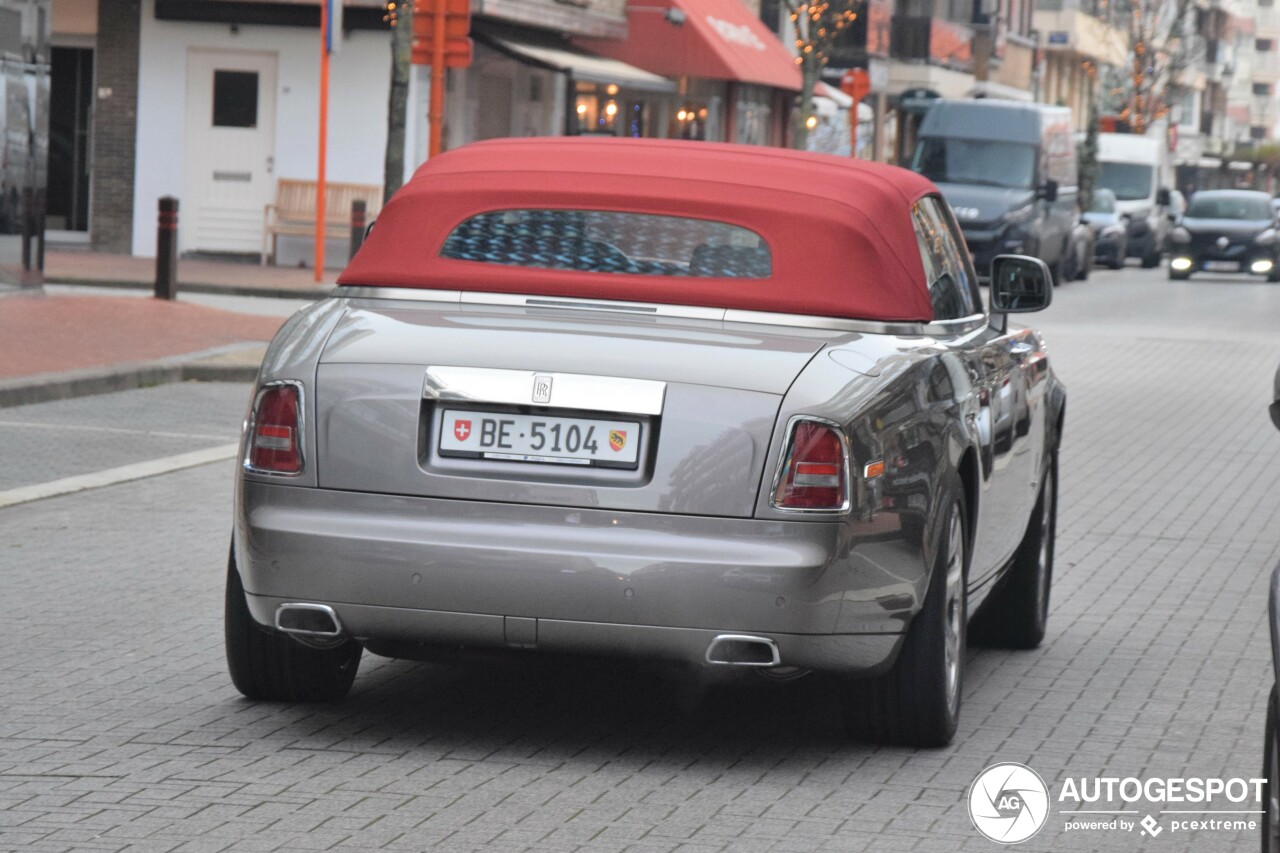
911, 97, 1079, 284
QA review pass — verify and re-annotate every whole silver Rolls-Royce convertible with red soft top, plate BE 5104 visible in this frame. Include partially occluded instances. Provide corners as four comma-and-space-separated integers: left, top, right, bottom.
225, 138, 1065, 744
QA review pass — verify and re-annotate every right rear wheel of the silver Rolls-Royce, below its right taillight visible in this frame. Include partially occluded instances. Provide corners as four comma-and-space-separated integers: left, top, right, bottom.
844, 485, 969, 747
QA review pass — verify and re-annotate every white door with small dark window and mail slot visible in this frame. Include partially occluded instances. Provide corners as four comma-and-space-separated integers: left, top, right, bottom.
181, 50, 275, 254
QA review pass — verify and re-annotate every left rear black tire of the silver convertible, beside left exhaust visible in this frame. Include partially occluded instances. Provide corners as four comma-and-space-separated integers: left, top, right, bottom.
224, 540, 362, 702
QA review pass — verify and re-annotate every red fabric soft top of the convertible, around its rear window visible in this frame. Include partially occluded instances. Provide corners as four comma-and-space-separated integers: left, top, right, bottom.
338, 137, 938, 323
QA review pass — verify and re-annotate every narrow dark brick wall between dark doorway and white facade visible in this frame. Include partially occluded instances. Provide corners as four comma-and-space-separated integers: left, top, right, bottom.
90, 0, 142, 255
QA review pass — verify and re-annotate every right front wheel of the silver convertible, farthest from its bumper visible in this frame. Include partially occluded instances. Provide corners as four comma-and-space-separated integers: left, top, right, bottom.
973, 451, 1057, 648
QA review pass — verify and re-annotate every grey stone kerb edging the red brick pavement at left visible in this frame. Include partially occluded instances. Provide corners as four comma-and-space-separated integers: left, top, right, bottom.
0, 347, 257, 409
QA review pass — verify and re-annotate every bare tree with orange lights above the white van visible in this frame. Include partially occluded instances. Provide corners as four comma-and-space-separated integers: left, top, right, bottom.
1103, 0, 1203, 133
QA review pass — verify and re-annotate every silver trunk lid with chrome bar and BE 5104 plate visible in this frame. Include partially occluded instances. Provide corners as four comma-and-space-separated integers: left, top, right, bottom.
315, 300, 841, 517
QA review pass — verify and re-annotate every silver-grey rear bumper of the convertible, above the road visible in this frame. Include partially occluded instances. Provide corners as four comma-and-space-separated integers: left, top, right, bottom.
236, 482, 927, 674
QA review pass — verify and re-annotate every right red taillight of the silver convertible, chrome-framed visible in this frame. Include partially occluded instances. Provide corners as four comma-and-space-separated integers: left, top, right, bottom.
773, 420, 849, 511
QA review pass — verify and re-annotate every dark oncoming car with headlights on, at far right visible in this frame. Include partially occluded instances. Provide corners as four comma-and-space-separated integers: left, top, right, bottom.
1169, 190, 1280, 282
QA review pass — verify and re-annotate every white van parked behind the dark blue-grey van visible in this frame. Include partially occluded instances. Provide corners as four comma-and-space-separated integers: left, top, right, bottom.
1096, 133, 1169, 268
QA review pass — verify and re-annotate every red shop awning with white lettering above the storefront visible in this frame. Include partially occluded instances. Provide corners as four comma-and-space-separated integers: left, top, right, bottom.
575, 0, 800, 91
